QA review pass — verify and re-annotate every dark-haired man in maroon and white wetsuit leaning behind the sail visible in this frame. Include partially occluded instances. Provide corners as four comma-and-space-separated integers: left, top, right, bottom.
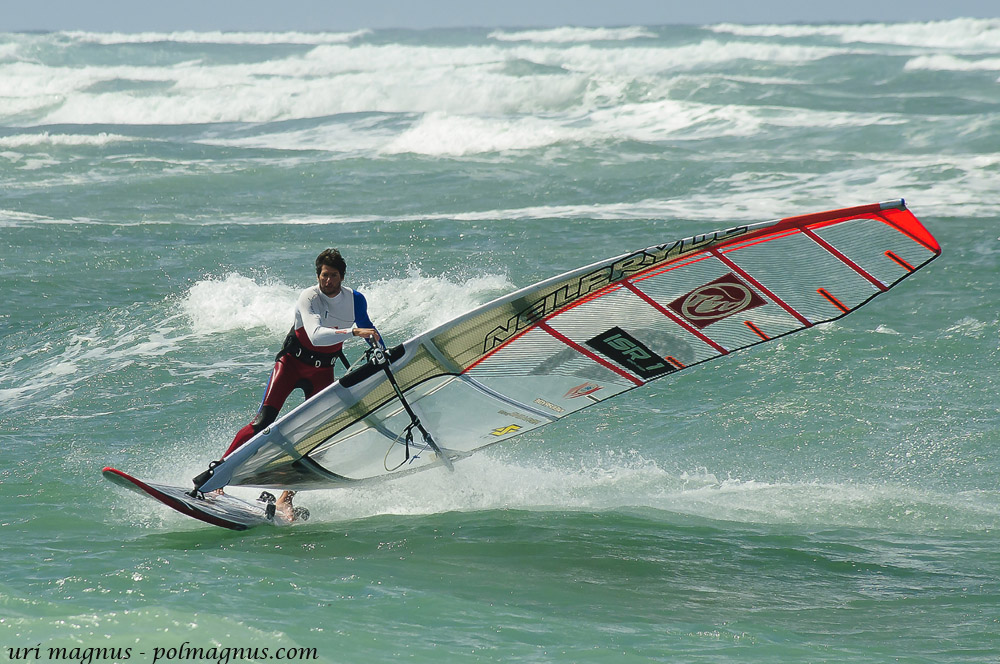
222, 249, 379, 458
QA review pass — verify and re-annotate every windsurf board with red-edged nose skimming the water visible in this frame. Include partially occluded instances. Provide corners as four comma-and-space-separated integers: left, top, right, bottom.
102, 467, 304, 530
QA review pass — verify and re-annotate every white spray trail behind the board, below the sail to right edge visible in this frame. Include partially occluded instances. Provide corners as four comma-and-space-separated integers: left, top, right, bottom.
298, 448, 1000, 530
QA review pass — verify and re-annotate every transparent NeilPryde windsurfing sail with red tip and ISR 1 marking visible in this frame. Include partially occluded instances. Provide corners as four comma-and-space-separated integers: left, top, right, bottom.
193, 200, 941, 491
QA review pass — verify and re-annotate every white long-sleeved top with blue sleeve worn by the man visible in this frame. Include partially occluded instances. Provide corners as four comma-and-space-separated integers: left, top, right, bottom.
295, 285, 375, 353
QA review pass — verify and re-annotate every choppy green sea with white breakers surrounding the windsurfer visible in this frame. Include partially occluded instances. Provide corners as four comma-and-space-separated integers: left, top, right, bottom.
0, 19, 1000, 664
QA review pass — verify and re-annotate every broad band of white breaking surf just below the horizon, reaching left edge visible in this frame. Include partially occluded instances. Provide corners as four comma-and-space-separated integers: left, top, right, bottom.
0, 39, 837, 124
